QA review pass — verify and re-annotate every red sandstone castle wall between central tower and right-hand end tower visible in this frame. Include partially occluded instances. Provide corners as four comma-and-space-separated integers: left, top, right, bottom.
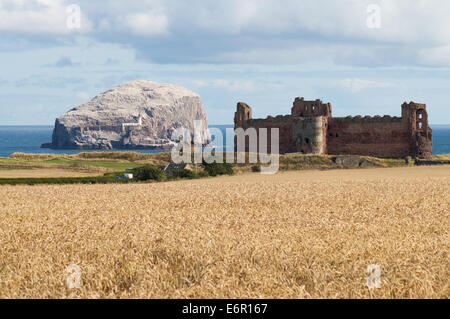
327, 117, 411, 157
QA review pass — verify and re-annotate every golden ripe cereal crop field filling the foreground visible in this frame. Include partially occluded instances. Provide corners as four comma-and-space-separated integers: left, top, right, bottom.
0, 166, 450, 298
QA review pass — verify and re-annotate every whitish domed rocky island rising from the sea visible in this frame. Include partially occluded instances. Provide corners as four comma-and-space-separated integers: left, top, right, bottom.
42, 81, 210, 149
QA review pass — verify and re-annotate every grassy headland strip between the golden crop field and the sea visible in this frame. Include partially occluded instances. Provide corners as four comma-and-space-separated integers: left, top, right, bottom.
0, 152, 450, 185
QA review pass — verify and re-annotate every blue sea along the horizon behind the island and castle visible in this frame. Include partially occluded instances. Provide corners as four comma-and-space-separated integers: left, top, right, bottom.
0, 125, 450, 157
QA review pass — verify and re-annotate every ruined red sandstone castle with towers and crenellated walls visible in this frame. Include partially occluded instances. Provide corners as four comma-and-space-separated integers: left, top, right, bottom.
234, 98, 433, 159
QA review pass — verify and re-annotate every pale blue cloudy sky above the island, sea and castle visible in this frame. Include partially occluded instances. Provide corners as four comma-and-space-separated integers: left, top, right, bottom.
0, 0, 450, 125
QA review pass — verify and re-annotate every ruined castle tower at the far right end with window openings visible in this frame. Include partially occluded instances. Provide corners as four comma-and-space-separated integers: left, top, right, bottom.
402, 102, 433, 159
